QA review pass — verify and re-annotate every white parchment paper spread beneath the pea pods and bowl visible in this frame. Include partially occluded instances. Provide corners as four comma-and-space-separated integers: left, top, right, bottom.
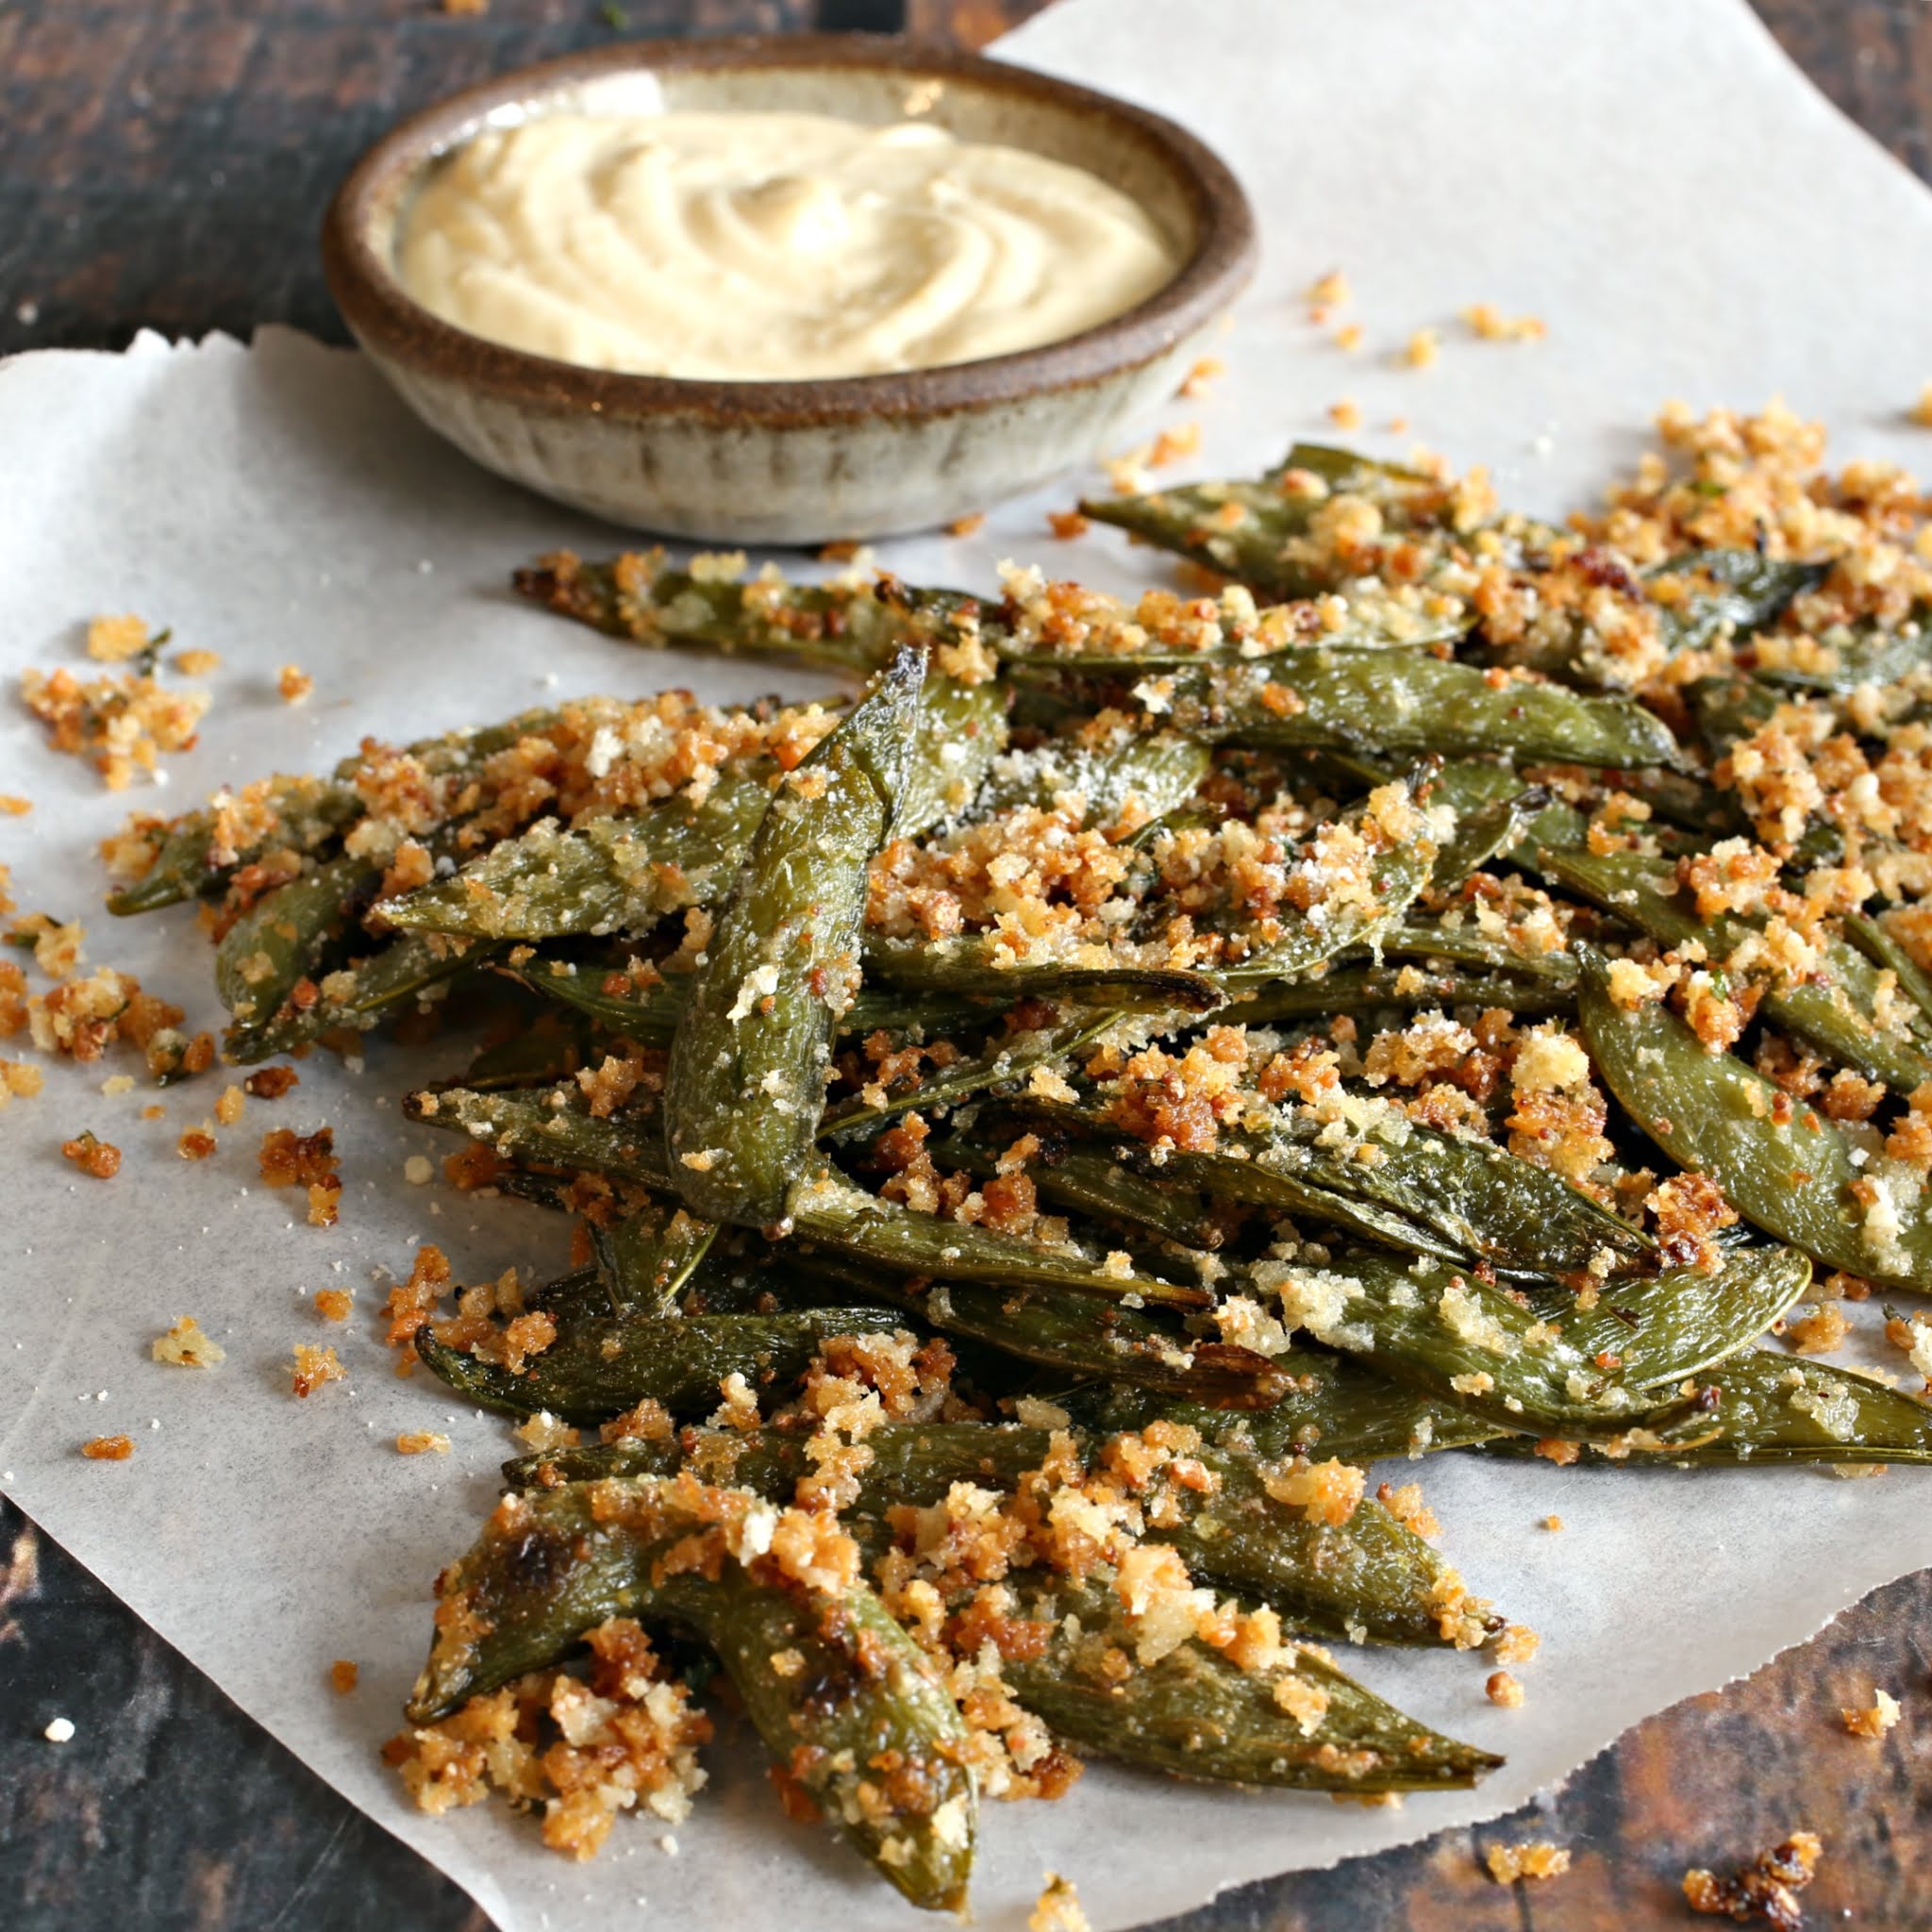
0, 0, 1932, 1932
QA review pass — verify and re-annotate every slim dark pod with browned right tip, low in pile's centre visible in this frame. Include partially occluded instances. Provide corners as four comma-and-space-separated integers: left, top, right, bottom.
802, 1252, 1285, 1408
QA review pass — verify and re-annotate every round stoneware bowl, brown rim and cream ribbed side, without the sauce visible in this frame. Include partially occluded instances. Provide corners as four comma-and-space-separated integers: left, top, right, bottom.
323, 35, 1256, 542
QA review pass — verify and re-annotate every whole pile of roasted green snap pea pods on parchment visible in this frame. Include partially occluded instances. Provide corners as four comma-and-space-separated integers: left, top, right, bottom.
112, 446, 1932, 1907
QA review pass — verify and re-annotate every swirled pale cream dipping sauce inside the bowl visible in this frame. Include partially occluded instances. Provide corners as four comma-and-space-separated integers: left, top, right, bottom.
396, 114, 1178, 383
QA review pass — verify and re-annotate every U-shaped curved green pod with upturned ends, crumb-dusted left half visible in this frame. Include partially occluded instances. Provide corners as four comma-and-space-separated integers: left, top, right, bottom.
1257, 1248, 1810, 1436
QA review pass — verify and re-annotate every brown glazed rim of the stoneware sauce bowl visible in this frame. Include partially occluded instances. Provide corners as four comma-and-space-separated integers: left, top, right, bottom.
323, 33, 1259, 429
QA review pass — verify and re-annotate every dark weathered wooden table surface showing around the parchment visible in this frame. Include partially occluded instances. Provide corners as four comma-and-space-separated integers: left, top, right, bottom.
0, 0, 1932, 1932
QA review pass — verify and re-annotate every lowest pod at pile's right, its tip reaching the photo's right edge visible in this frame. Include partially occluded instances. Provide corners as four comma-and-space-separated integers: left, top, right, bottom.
1486, 1349, 1932, 1468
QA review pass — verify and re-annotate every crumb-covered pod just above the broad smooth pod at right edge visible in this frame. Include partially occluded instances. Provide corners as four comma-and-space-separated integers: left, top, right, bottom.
1543, 852, 1932, 1093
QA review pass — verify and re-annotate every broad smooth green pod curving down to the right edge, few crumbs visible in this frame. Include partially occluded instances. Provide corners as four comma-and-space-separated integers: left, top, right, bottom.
1576, 949, 1932, 1292
